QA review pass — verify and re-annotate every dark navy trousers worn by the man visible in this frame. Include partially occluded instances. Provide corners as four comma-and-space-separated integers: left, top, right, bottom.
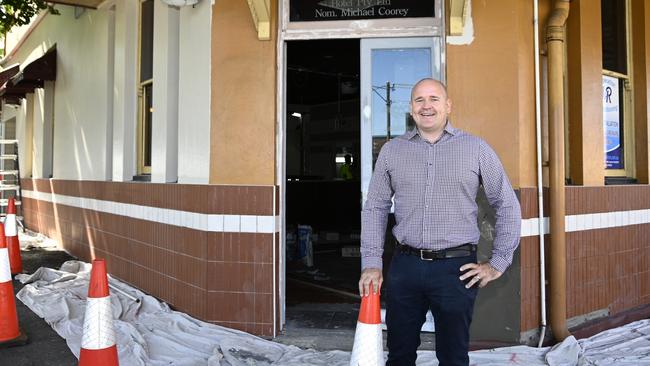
386, 253, 478, 366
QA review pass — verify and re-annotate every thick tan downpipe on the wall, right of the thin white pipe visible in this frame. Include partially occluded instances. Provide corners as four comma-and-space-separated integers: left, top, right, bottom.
546, 0, 571, 341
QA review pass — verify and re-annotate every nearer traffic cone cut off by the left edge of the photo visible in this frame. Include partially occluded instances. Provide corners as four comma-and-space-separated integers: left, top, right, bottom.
0, 225, 27, 347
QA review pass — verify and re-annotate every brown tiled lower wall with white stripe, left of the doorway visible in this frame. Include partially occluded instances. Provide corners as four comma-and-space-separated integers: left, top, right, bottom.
22, 179, 279, 335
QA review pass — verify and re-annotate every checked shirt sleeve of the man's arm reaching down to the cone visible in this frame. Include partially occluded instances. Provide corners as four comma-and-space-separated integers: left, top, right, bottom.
361, 143, 394, 270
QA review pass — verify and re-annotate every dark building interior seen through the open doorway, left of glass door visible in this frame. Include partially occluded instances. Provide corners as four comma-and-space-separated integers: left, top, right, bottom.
286, 39, 361, 325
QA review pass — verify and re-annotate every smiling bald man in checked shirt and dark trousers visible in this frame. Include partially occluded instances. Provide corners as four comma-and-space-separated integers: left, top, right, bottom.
359, 79, 521, 366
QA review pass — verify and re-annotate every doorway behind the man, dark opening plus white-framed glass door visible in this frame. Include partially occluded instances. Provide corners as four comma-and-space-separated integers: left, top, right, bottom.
284, 37, 442, 329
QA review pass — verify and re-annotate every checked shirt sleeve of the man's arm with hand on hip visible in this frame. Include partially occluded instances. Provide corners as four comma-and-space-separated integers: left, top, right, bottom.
479, 141, 521, 273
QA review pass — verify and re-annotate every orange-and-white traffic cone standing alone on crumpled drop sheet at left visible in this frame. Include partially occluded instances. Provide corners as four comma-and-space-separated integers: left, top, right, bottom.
79, 259, 119, 366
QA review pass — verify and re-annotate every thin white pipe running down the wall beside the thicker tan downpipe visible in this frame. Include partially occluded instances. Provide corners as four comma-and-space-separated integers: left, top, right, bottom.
533, 0, 546, 347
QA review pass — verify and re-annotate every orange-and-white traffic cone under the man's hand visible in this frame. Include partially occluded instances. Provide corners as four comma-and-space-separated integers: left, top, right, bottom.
350, 285, 385, 366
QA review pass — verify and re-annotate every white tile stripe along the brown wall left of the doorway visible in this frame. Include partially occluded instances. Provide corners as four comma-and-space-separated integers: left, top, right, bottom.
22, 189, 280, 234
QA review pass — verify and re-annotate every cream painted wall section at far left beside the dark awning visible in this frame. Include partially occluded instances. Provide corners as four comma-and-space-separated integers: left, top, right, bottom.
9, 6, 108, 179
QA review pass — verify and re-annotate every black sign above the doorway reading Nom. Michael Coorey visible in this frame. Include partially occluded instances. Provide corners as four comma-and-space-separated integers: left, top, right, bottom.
290, 0, 435, 22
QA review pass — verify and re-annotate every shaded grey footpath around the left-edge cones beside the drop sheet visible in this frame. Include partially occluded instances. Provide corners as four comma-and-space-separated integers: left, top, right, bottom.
0, 248, 78, 366
